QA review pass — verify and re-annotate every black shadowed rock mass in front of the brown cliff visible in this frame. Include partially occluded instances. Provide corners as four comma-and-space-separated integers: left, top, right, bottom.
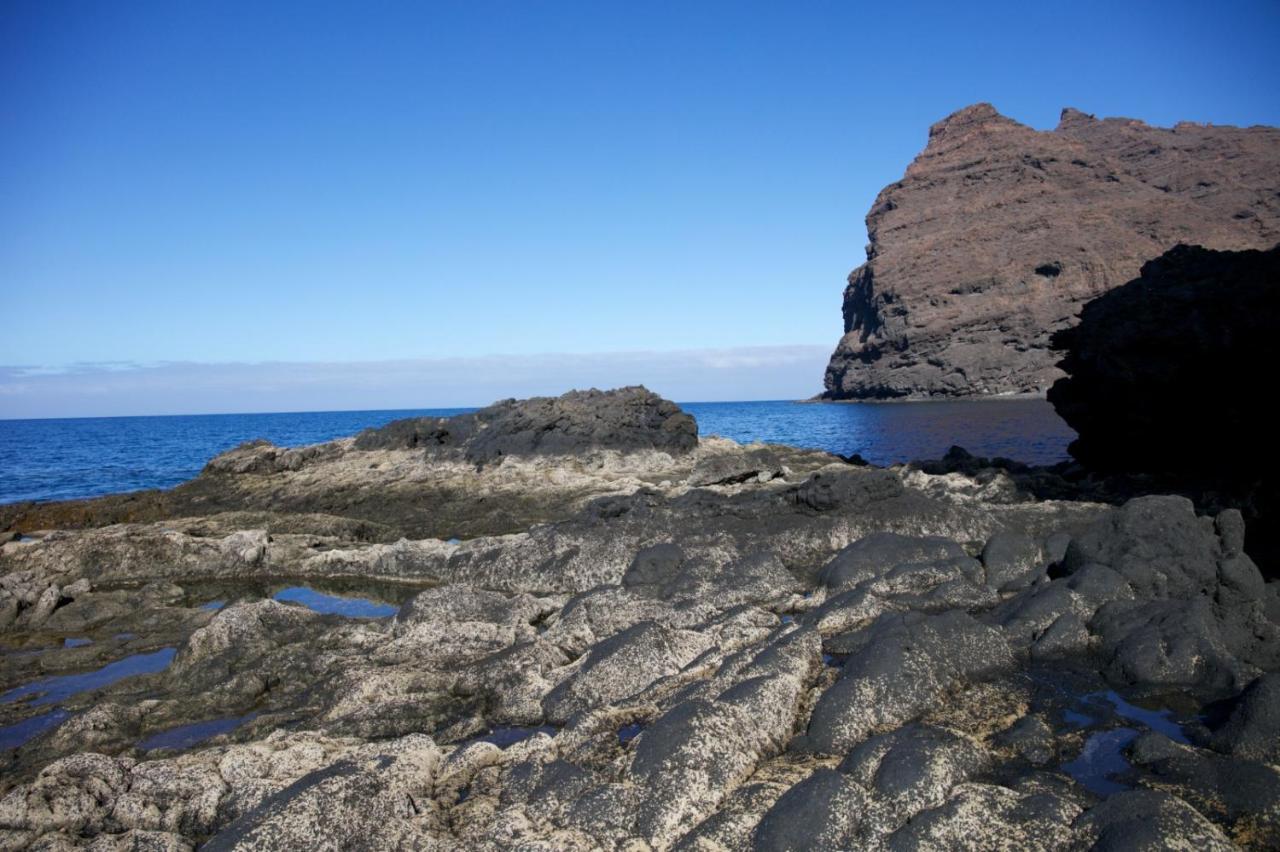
1048, 246, 1280, 571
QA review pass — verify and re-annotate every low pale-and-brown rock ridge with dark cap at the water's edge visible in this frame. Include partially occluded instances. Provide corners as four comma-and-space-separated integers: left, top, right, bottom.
0, 388, 721, 542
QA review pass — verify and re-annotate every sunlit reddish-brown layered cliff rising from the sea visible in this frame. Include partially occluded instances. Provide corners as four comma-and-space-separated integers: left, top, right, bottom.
824, 104, 1280, 399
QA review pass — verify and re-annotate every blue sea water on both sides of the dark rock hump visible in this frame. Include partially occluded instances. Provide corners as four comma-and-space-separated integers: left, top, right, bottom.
0, 399, 1075, 503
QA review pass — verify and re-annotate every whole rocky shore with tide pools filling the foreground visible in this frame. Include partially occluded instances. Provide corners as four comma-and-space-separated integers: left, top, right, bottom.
0, 388, 1280, 849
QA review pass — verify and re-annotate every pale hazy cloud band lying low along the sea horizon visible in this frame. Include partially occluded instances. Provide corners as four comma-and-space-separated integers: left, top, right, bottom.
0, 345, 831, 418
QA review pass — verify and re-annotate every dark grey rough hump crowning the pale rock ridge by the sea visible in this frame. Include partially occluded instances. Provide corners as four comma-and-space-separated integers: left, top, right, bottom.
356, 386, 698, 464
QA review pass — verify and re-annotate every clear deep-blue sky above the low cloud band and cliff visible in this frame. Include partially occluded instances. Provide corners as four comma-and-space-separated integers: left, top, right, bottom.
0, 0, 1280, 417
